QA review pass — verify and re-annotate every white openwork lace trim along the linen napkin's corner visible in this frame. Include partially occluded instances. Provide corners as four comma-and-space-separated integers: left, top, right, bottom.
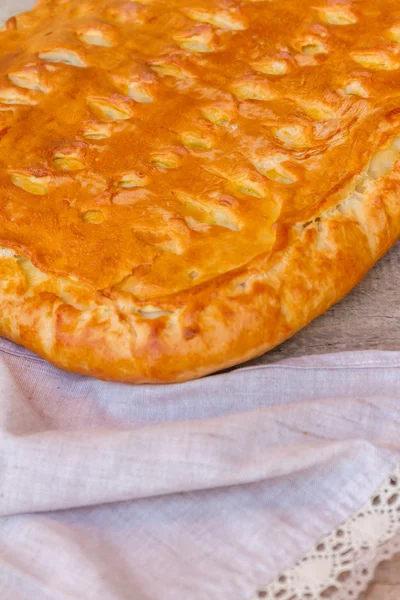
251, 466, 400, 600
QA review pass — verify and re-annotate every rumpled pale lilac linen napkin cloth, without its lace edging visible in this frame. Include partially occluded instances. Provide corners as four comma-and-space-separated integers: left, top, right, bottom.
0, 340, 400, 600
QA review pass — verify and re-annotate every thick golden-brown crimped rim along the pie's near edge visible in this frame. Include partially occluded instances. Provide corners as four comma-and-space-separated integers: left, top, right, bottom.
0, 159, 400, 383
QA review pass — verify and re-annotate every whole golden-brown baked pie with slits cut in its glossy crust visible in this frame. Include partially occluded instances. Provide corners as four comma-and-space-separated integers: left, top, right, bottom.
0, 0, 400, 383
